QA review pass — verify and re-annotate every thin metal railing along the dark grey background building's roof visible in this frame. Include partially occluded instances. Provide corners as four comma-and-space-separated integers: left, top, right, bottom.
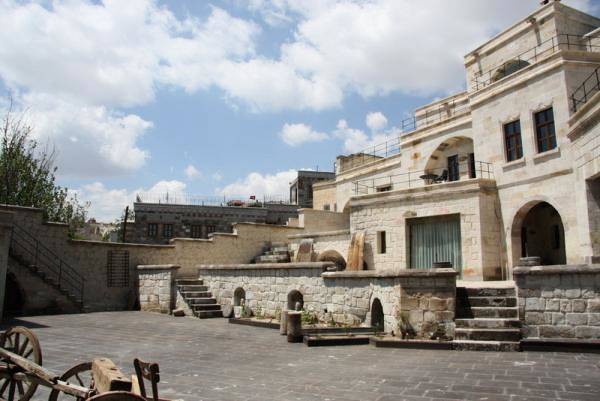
135, 192, 295, 207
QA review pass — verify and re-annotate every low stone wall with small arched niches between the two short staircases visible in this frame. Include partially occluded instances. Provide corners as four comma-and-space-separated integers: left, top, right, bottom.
199, 263, 457, 336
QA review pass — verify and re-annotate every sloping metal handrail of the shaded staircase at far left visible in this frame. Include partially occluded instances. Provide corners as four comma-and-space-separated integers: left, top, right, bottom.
10, 226, 85, 303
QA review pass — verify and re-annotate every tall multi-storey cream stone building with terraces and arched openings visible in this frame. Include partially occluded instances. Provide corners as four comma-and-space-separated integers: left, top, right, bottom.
314, 2, 600, 280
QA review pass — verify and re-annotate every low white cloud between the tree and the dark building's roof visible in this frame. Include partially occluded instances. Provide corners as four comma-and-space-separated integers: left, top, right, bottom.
75, 180, 186, 222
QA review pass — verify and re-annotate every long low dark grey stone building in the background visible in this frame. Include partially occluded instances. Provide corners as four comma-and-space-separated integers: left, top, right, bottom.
132, 201, 298, 244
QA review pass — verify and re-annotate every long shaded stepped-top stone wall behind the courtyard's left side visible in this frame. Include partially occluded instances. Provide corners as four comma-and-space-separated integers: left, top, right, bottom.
0, 205, 303, 314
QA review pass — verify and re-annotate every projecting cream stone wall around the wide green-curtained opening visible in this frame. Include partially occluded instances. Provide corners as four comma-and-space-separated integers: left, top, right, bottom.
351, 179, 501, 280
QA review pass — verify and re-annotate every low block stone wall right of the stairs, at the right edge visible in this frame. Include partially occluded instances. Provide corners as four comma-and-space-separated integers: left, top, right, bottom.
513, 265, 600, 339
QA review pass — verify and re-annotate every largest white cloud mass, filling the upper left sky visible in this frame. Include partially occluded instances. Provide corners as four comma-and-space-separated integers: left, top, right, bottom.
0, 0, 259, 177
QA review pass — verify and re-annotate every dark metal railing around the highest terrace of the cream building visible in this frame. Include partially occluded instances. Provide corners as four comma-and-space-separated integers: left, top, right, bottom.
471, 33, 600, 90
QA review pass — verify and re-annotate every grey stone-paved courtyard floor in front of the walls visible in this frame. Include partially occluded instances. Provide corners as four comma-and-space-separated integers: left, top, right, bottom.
1, 312, 600, 401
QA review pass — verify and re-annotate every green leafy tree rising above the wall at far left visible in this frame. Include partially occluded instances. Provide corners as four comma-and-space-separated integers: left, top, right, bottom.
0, 103, 89, 236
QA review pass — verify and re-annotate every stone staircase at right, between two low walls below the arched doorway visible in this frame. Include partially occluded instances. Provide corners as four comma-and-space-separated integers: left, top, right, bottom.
453, 286, 521, 351
